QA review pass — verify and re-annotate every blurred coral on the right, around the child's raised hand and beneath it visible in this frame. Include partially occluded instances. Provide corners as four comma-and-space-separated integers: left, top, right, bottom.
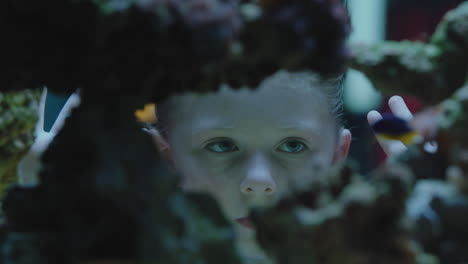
252, 1, 468, 264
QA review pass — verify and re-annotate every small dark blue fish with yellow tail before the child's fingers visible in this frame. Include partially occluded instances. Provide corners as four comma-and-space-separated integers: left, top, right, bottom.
372, 113, 419, 145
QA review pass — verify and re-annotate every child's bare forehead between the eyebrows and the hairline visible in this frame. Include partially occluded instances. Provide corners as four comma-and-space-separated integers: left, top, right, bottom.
166, 80, 330, 126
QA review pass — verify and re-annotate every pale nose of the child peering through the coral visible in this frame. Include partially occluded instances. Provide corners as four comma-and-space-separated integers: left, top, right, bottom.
240, 154, 276, 196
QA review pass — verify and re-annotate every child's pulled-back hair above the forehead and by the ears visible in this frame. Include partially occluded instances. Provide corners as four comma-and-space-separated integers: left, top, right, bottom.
156, 70, 345, 137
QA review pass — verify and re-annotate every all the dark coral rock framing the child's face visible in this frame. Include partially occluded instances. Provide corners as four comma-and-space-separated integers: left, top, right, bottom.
4, 0, 468, 264
